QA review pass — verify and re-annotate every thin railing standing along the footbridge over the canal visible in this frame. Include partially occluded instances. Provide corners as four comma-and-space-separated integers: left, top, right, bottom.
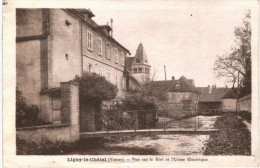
92, 109, 208, 132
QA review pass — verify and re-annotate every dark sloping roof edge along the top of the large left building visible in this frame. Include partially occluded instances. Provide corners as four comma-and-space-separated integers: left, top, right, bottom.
63, 8, 131, 54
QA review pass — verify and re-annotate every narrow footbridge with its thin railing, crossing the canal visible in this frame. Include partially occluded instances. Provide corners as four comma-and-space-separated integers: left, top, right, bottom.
80, 110, 219, 139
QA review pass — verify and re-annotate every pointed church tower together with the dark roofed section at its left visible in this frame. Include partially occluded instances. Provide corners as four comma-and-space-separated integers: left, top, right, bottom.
126, 43, 151, 88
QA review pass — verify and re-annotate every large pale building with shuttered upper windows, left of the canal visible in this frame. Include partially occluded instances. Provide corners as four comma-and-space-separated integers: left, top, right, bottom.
16, 9, 129, 125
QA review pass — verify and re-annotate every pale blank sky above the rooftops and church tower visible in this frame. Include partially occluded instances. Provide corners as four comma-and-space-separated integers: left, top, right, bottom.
86, 0, 252, 87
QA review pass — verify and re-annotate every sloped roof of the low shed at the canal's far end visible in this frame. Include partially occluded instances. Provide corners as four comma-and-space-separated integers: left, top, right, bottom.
198, 87, 231, 102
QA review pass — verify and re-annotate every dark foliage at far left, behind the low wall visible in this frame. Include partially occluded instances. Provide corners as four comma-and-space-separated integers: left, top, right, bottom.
16, 91, 50, 127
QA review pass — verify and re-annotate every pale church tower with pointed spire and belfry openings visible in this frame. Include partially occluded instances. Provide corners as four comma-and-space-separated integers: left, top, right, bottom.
131, 42, 151, 84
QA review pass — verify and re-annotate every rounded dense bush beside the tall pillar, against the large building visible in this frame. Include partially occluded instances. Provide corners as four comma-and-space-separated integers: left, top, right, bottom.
74, 73, 118, 102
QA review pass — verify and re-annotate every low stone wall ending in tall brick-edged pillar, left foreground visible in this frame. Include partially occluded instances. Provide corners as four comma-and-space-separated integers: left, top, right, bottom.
16, 82, 79, 144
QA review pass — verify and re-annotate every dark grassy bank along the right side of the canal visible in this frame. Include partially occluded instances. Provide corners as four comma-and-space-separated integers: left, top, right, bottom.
204, 113, 251, 155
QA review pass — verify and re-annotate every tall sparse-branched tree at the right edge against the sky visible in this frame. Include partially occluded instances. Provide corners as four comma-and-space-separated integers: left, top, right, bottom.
214, 10, 251, 96
